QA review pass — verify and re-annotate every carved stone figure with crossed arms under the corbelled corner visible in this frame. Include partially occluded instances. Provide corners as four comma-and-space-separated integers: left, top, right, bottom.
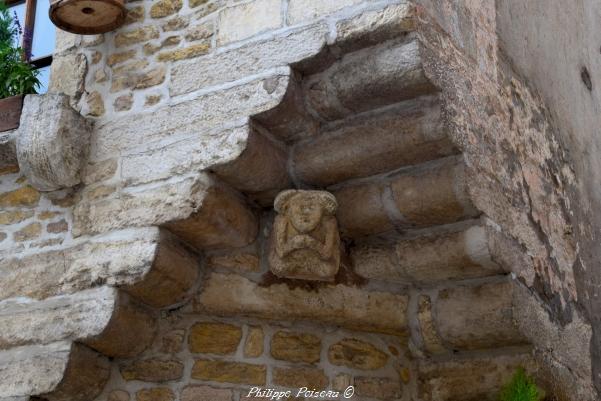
269, 190, 340, 281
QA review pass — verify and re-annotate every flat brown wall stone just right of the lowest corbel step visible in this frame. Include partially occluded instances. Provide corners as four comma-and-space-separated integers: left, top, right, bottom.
120, 359, 184, 382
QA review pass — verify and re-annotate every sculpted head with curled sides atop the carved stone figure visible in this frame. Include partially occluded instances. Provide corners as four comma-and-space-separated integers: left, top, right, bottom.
274, 190, 338, 233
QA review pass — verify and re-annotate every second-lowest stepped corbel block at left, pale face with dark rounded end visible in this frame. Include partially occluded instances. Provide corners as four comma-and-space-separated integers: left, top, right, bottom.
0, 287, 155, 357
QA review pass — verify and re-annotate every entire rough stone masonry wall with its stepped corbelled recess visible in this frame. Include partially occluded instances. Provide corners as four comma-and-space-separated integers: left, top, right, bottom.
0, 0, 599, 401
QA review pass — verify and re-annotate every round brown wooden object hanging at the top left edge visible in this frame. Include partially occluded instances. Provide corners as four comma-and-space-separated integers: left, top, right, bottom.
50, 0, 127, 35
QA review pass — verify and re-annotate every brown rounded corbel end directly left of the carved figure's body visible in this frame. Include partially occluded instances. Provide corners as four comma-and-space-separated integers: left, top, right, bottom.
164, 186, 259, 249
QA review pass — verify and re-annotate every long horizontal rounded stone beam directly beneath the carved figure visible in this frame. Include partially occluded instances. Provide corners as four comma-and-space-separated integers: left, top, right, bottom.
195, 273, 407, 334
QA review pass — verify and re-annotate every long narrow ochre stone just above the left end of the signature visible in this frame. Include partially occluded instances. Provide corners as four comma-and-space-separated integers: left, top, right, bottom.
192, 360, 267, 386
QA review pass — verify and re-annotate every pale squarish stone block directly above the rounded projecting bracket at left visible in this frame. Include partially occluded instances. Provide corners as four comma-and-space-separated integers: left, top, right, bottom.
48, 53, 88, 100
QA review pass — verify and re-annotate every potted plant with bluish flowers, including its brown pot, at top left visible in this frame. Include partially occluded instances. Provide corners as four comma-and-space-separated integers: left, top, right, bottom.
0, 0, 40, 132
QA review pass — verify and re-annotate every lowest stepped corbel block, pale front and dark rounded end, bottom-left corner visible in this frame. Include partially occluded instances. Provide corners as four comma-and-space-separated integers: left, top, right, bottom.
0, 342, 110, 401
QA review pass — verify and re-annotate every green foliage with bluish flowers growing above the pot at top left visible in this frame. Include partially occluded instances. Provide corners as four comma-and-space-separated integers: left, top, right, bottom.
0, 0, 40, 99
